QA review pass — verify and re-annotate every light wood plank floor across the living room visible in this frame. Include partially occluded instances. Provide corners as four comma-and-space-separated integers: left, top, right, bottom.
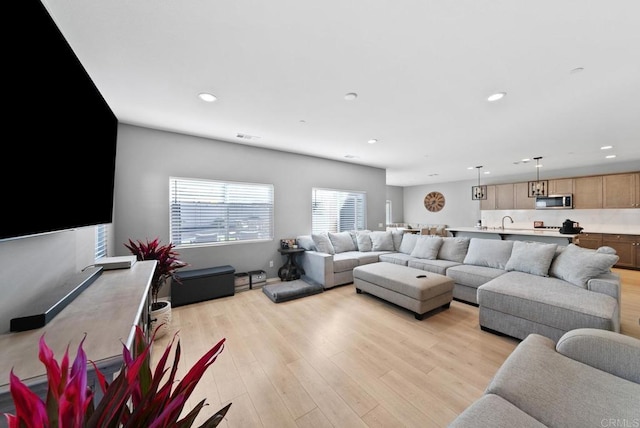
153, 269, 640, 428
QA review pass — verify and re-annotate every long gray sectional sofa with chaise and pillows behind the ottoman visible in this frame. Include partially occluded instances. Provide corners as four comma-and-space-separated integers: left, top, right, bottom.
298, 231, 620, 341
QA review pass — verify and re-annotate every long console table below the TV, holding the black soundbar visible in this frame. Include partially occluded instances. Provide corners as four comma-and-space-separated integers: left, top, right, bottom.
0, 260, 156, 414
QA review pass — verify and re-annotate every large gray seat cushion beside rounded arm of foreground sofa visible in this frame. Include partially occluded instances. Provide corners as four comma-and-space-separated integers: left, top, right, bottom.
485, 334, 640, 427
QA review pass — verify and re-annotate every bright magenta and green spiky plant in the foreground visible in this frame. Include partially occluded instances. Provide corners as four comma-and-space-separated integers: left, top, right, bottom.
5, 327, 231, 428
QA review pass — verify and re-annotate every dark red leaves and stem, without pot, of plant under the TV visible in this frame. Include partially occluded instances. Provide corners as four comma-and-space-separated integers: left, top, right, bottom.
124, 238, 189, 310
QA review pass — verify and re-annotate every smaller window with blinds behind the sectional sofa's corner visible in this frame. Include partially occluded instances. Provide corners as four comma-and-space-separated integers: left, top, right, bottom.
311, 188, 367, 233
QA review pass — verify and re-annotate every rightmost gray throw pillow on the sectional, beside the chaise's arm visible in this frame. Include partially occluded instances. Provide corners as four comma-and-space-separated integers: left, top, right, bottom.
549, 244, 619, 288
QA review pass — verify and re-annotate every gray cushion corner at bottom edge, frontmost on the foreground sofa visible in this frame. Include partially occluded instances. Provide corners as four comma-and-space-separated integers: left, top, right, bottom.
448, 394, 546, 428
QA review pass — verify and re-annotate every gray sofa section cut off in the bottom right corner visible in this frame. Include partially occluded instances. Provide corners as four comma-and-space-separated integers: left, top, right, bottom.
449, 329, 640, 428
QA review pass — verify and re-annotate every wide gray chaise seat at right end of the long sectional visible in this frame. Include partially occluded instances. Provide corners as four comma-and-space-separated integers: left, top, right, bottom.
480, 268, 619, 331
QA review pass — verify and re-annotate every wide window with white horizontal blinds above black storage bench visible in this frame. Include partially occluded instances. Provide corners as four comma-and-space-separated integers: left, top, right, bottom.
169, 177, 273, 246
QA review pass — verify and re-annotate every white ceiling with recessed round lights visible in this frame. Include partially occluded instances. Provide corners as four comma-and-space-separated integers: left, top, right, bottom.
43, 0, 640, 186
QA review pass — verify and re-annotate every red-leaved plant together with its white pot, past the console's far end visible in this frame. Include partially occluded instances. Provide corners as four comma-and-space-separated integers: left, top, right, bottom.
124, 238, 188, 337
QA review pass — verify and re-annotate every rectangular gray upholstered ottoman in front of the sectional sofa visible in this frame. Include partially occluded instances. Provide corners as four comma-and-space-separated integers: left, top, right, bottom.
353, 262, 453, 320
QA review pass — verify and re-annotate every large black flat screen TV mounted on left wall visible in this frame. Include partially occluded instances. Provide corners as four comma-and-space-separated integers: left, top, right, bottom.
0, 0, 118, 240
